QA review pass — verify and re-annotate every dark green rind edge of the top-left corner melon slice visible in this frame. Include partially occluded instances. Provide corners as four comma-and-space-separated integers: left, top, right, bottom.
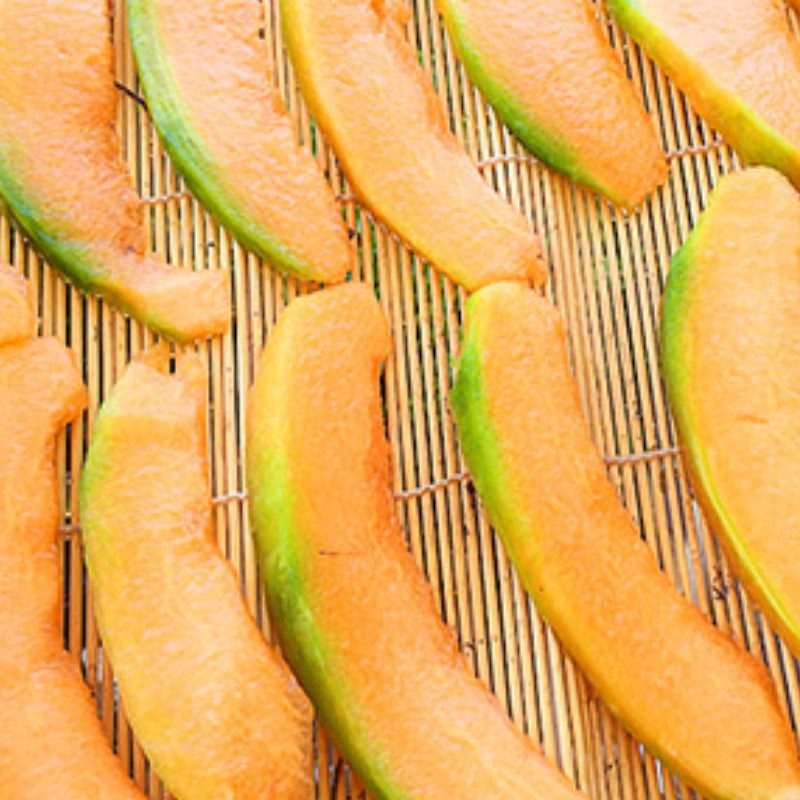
0, 143, 202, 343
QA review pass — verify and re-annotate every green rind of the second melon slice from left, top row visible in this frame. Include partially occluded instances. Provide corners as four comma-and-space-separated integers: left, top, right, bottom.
128, 0, 330, 282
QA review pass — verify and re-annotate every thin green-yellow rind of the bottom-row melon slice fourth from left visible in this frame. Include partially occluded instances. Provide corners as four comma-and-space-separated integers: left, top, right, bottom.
450, 286, 732, 797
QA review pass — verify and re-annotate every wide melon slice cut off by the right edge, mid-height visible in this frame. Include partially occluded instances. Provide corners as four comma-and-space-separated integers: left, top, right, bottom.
661, 167, 800, 668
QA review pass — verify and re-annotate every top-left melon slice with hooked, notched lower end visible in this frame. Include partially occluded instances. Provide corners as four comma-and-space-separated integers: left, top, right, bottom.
0, 0, 230, 341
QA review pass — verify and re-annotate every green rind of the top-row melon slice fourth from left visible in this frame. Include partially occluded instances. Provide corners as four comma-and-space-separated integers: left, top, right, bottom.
439, 0, 631, 207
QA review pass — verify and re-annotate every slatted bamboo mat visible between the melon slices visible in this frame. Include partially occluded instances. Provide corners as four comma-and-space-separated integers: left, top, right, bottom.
7, 0, 800, 800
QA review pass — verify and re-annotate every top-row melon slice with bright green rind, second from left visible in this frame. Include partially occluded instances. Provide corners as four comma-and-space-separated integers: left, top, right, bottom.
128, 0, 351, 282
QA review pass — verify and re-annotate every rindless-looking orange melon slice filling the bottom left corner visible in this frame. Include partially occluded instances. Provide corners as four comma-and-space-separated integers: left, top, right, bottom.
0, 332, 143, 800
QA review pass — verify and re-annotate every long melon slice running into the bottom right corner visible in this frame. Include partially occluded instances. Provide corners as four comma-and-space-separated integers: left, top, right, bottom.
452, 284, 800, 800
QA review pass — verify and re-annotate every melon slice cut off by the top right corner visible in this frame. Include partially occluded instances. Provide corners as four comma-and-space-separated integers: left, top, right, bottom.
609, 0, 800, 185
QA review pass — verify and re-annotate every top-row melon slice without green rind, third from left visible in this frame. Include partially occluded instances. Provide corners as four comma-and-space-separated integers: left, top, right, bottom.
281, 0, 544, 289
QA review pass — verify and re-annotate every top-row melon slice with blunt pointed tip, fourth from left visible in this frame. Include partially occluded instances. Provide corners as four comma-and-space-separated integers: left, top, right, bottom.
437, 0, 667, 208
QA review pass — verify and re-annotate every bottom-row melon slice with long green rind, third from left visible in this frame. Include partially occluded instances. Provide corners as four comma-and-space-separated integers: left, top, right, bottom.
247, 284, 580, 800
